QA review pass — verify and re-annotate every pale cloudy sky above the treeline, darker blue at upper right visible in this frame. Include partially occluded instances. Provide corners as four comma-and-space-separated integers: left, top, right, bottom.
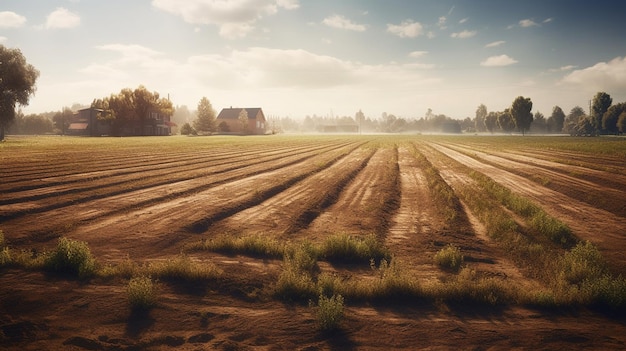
0, 0, 626, 119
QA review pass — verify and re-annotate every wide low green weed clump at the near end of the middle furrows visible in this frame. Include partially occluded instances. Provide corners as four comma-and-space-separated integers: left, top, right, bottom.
320, 234, 391, 262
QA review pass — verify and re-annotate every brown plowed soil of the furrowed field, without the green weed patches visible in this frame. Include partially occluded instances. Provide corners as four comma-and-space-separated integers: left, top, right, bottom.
0, 136, 626, 350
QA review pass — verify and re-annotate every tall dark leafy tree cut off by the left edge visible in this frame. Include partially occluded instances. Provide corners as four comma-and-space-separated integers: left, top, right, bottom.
0, 45, 39, 141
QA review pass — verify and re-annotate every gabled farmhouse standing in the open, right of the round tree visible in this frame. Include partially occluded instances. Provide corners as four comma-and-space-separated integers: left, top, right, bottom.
215, 107, 266, 135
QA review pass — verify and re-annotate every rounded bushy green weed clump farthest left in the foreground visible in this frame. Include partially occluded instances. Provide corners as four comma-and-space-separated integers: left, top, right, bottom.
44, 237, 96, 279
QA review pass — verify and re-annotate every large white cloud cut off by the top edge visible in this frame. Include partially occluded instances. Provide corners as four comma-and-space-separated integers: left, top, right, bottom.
152, 0, 300, 39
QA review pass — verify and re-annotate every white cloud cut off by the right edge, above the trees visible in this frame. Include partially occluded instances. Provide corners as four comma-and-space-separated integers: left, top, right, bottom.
562, 57, 626, 92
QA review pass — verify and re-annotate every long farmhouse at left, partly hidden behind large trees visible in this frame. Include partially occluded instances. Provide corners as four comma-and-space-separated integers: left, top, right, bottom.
68, 107, 176, 136
